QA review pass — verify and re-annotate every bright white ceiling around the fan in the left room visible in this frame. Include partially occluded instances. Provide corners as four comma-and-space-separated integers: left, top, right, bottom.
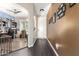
0, 3, 28, 17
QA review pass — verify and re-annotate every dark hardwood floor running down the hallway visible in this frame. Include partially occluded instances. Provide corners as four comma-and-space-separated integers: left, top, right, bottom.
5, 39, 56, 56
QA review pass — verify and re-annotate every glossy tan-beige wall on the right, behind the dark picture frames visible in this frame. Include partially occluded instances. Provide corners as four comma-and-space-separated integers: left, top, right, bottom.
47, 4, 79, 55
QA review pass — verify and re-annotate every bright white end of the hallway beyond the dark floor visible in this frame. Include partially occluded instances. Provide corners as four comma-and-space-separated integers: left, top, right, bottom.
38, 16, 47, 38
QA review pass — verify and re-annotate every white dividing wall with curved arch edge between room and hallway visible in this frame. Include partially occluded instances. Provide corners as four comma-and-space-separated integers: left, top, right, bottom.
18, 3, 36, 47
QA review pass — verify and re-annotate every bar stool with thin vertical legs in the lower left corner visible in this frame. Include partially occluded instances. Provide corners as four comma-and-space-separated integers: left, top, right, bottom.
1, 35, 12, 55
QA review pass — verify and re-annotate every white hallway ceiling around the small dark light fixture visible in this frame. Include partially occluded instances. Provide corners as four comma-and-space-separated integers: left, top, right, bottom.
34, 3, 50, 16
